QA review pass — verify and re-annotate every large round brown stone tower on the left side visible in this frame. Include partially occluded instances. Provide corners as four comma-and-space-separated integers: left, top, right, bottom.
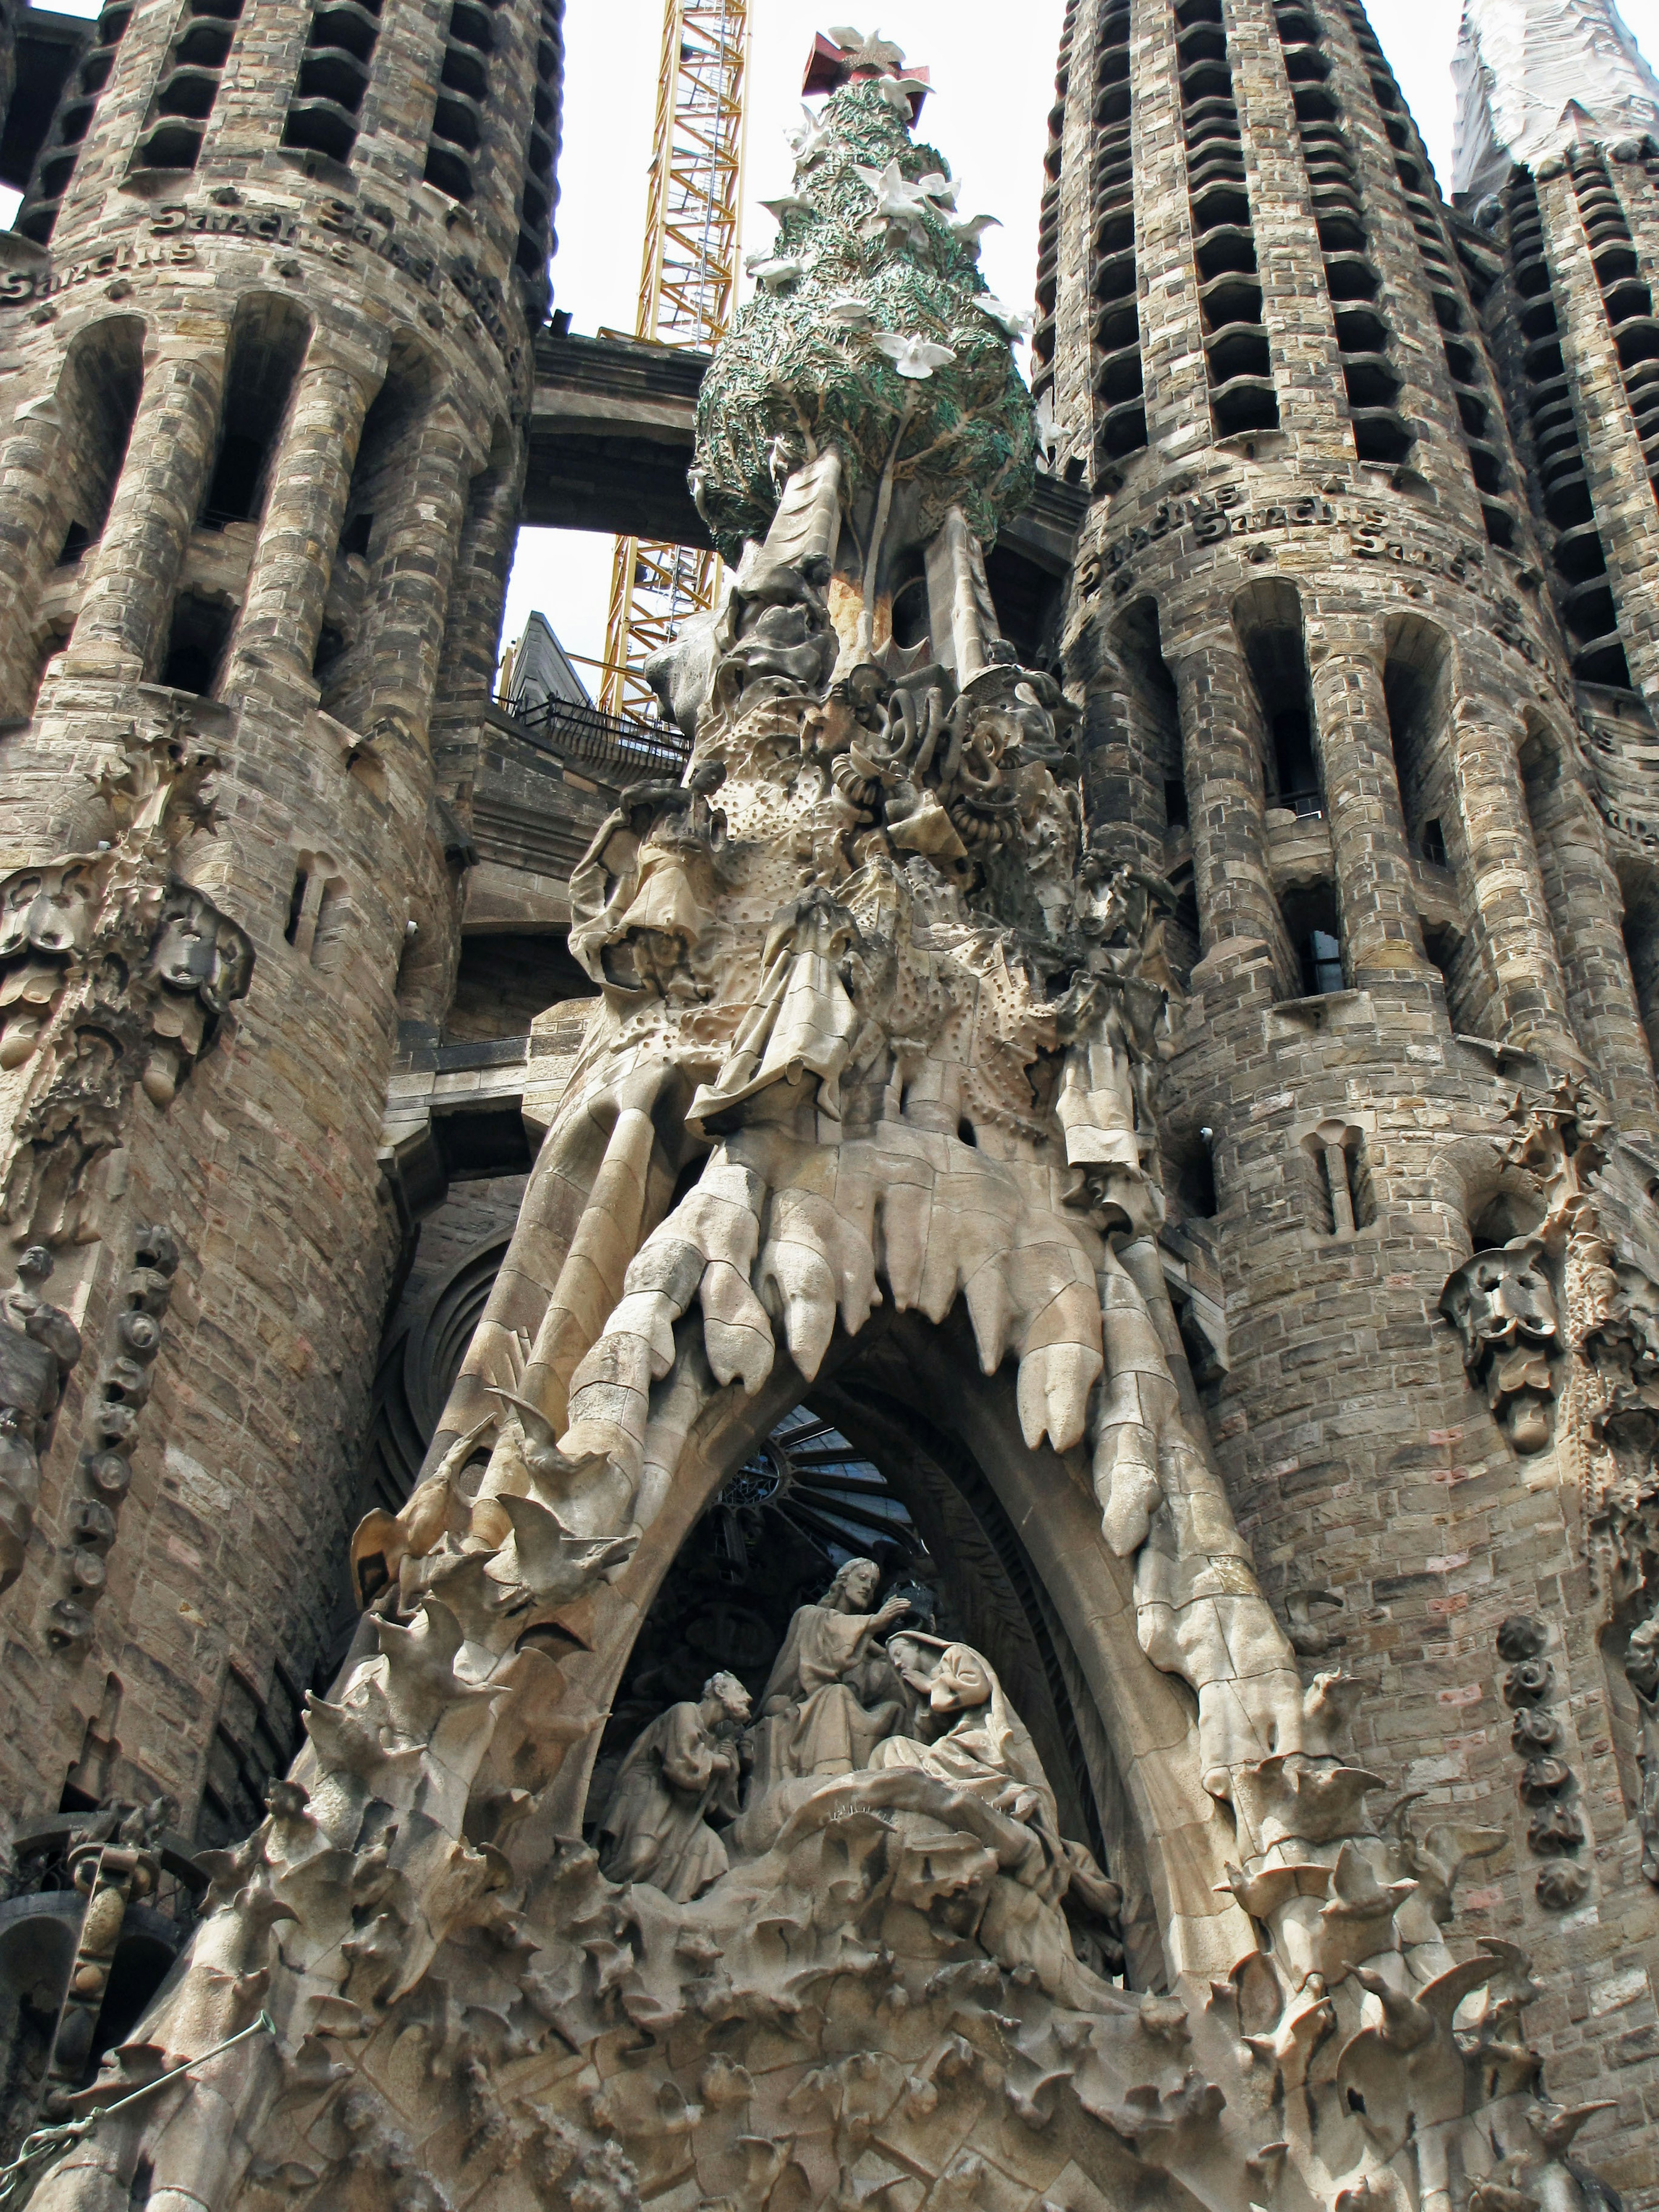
0, 0, 562, 1849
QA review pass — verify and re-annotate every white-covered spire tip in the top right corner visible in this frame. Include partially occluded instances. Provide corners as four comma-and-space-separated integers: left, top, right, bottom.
1451, 0, 1659, 199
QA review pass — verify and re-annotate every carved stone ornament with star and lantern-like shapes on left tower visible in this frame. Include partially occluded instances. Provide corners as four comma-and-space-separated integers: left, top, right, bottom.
0, 723, 252, 1246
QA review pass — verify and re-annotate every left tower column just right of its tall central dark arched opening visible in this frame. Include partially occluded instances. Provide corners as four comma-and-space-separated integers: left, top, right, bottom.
232, 340, 383, 677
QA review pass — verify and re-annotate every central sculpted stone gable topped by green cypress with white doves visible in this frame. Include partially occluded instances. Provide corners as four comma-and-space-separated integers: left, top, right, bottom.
13, 33, 1606, 2212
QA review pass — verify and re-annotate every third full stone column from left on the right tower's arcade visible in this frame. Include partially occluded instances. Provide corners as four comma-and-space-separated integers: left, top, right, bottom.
1451, 706, 1582, 1059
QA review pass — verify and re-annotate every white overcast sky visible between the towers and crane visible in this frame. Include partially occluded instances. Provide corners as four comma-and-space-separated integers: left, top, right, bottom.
0, 0, 1659, 675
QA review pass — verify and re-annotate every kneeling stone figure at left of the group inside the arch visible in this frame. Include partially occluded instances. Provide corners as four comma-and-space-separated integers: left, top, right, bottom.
600, 1675, 750, 1904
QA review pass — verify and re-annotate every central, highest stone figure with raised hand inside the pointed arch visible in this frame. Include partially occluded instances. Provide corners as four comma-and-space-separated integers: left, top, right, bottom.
761, 1560, 909, 1781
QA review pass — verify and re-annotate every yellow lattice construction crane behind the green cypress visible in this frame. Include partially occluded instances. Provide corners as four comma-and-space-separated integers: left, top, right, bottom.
600, 0, 750, 715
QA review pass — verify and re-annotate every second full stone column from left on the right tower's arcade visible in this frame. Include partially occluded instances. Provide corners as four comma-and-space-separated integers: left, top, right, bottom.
1312, 652, 1424, 984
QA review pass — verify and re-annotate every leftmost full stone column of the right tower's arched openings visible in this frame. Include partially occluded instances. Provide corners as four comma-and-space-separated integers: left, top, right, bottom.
1175, 635, 1294, 978
